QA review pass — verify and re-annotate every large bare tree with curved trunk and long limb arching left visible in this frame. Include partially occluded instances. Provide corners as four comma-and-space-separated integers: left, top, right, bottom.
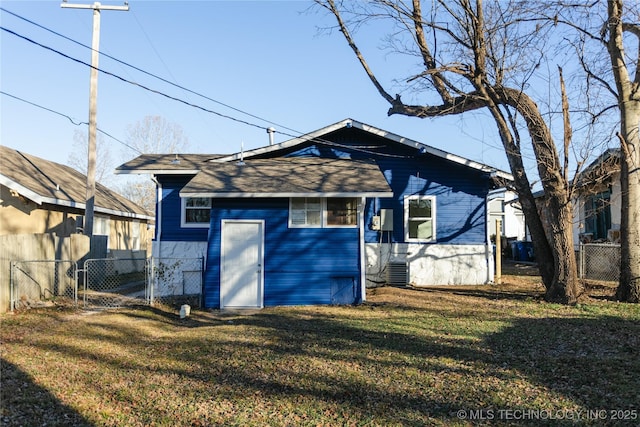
316, 0, 581, 303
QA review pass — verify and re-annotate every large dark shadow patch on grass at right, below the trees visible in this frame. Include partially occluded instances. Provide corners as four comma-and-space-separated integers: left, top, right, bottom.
485, 316, 640, 416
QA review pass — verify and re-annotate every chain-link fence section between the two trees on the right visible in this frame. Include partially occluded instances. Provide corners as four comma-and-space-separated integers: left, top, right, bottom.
578, 243, 620, 282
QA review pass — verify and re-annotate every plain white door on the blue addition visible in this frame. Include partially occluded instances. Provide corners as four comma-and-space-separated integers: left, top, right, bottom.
220, 220, 264, 308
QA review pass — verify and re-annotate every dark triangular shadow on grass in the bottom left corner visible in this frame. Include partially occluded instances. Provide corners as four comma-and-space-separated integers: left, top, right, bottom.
0, 359, 93, 426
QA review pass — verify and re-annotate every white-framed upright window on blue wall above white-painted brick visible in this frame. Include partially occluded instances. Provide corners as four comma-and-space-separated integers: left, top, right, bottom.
404, 196, 436, 242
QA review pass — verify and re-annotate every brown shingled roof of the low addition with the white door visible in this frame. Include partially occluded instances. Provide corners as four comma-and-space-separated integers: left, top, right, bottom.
180, 157, 393, 197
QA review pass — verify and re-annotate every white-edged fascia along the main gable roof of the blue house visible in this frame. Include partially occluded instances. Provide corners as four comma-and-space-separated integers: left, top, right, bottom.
218, 119, 513, 181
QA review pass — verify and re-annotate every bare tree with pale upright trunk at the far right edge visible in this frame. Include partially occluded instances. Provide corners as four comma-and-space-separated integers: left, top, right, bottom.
539, 0, 640, 303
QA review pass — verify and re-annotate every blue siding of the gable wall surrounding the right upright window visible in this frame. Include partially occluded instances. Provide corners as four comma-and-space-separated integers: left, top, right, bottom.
271, 128, 489, 245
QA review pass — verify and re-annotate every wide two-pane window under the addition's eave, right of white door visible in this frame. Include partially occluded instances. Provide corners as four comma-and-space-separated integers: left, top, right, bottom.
289, 197, 358, 228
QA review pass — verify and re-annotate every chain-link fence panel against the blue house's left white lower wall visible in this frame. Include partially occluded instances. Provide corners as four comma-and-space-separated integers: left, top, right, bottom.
146, 257, 204, 307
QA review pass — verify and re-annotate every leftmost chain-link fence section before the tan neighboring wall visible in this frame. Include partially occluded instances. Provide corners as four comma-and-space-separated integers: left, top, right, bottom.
10, 260, 78, 311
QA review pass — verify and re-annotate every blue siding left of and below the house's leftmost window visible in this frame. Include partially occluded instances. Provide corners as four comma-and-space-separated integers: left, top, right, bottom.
156, 175, 209, 242
